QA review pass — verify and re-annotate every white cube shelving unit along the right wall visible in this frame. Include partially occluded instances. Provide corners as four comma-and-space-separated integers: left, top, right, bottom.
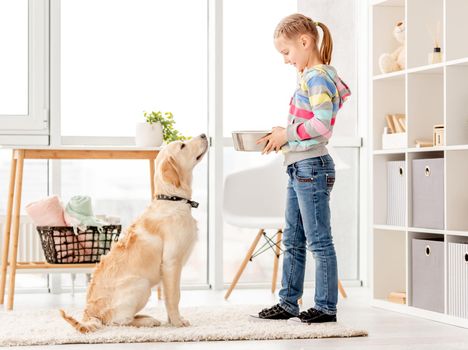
369, 0, 468, 328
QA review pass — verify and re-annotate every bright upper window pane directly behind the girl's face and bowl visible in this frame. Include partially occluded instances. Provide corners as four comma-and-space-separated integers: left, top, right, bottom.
223, 0, 297, 137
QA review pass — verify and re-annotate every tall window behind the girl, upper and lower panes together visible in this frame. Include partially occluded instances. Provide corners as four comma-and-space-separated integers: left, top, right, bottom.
223, 0, 360, 283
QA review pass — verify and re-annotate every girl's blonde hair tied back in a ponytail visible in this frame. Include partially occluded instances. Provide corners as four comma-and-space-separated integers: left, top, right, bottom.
274, 13, 333, 64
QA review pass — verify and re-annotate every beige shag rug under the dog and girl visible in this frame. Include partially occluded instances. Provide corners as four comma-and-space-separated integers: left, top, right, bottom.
0, 305, 367, 346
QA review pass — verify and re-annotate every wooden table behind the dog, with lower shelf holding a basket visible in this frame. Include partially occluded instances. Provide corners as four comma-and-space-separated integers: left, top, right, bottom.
0, 147, 160, 310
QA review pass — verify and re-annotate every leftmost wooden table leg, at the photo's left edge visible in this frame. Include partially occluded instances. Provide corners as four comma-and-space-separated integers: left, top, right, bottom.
0, 151, 16, 305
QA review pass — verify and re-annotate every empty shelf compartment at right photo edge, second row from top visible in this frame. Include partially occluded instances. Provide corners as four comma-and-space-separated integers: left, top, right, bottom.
445, 64, 468, 145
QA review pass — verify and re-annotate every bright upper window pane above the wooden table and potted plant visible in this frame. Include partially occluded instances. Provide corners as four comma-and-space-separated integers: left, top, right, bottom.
60, 0, 208, 136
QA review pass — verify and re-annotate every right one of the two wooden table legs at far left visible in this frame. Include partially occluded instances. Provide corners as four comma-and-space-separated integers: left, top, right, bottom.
7, 150, 24, 310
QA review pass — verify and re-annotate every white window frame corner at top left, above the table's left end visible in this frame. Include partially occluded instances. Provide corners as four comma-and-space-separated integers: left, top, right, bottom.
0, 0, 49, 145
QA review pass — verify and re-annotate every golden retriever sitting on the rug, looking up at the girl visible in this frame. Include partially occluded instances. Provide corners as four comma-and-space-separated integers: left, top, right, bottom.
60, 134, 208, 333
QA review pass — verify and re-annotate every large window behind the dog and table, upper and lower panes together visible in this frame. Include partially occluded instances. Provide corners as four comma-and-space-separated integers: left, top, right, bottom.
60, 0, 208, 284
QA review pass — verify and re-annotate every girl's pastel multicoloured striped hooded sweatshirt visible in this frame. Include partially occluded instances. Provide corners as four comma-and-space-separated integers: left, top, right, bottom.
282, 64, 351, 165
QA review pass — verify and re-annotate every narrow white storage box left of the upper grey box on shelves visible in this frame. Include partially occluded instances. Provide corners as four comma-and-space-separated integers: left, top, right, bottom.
387, 160, 406, 226
